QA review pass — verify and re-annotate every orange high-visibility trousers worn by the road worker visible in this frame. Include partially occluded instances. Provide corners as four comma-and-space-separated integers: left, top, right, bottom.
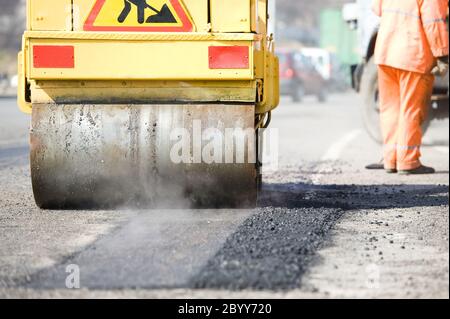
378, 65, 434, 170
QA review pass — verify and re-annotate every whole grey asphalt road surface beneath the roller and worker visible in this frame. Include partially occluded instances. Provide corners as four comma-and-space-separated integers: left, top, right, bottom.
0, 93, 449, 298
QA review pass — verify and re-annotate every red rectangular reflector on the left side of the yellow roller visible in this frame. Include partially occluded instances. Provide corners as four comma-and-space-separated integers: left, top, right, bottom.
33, 45, 75, 69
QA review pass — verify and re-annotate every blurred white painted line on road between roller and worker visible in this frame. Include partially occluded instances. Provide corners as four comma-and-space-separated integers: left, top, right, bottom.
311, 130, 362, 184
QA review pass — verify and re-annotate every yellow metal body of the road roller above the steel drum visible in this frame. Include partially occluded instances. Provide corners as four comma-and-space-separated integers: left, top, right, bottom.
18, 0, 279, 114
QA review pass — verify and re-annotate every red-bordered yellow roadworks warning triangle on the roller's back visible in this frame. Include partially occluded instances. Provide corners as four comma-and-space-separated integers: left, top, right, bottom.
84, 0, 193, 32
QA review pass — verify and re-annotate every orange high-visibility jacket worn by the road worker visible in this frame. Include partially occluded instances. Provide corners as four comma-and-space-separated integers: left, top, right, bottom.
373, 0, 448, 73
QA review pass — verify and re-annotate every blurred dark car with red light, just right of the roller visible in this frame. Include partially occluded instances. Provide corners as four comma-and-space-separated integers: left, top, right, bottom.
278, 51, 327, 102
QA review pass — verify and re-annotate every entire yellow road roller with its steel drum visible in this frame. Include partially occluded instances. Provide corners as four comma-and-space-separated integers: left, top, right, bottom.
18, 0, 279, 209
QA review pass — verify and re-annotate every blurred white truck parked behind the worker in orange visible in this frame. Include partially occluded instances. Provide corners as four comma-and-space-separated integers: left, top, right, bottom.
343, 0, 449, 142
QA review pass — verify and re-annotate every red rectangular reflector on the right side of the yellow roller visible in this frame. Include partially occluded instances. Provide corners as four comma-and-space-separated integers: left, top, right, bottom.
209, 46, 249, 69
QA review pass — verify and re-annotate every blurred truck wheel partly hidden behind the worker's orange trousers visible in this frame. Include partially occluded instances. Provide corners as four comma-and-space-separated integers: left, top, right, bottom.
360, 57, 431, 144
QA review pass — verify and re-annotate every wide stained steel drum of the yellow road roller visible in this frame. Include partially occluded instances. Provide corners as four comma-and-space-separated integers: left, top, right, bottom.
30, 104, 257, 209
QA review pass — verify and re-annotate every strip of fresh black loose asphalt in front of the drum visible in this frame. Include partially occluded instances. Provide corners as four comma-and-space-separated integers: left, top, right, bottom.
190, 207, 343, 290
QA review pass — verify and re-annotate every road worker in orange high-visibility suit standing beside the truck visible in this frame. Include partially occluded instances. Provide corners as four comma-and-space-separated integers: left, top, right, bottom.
373, 0, 449, 175
